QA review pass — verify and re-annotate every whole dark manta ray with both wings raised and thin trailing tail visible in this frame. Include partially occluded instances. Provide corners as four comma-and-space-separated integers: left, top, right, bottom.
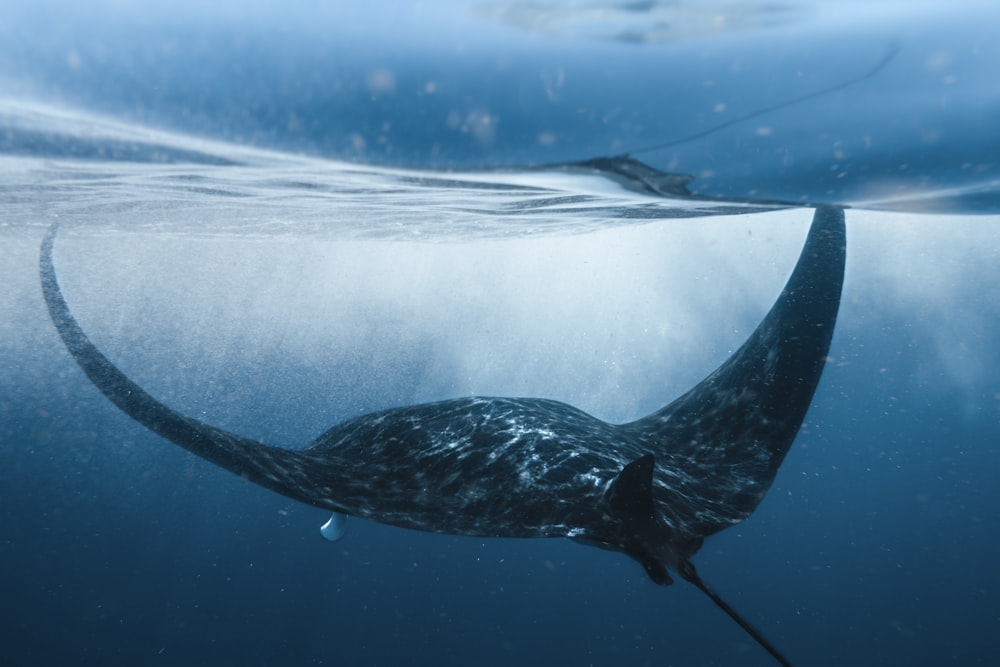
39, 207, 846, 665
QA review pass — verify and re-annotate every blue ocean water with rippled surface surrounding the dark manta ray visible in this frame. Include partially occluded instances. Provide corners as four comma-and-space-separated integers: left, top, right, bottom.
0, 1, 1000, 666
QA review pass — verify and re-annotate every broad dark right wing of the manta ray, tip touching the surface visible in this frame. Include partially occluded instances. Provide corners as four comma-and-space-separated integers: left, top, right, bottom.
625, 208, 846, 537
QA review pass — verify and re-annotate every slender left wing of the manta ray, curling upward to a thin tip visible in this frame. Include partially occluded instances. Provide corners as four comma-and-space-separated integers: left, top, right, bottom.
39, 224, 328, 505
